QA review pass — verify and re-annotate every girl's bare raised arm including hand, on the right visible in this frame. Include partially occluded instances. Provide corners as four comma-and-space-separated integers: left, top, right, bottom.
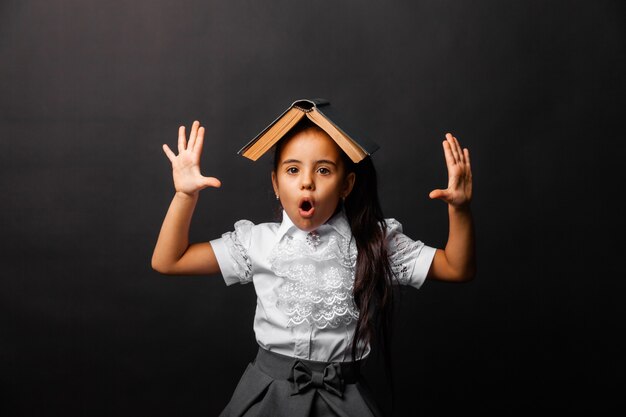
427, 133, 476, 282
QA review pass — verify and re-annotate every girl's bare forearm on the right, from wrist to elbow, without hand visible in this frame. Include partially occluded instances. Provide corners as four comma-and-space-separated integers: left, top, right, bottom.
444, 205, 476, 281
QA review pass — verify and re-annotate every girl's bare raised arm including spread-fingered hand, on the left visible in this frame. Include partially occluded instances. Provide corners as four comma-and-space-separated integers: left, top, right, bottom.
152, 121, 221, 275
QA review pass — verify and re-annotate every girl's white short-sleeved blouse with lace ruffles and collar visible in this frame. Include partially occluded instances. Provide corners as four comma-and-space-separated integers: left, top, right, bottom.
211, 211, 436, 362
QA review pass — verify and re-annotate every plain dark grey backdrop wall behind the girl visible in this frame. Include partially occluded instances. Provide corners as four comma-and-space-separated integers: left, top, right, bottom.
0, 0, 626, 416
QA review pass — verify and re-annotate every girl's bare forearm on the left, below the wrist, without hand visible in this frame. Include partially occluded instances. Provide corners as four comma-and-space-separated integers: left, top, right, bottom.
152, 192, 199, 270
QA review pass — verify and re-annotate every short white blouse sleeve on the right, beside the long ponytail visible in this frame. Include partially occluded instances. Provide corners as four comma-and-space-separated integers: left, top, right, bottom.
385, 219, 437, 288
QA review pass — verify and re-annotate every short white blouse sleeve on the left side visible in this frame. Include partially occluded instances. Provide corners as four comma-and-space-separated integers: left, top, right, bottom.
211, 220, 254, 285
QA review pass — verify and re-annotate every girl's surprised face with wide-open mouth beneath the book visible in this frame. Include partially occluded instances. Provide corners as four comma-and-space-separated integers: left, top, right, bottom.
272, 128, 355, 232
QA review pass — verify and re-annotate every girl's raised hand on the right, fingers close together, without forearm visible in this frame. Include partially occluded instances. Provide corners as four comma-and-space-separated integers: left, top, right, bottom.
429, 133, 472, 208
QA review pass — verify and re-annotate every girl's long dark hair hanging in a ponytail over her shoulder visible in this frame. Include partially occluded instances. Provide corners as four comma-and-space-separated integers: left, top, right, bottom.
274, 118, 393, 392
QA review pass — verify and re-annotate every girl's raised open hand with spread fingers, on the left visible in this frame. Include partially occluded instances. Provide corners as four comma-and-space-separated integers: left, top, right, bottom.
163, 120, 222, 196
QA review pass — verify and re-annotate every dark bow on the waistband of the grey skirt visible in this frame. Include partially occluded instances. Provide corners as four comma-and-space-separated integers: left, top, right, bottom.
288, 361, 343, 397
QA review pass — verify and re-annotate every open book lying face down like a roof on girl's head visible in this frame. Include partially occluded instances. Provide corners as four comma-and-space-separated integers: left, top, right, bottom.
237, 98, 379, 163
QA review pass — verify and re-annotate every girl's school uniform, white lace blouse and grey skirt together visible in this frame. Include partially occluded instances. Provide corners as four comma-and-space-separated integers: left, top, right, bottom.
211, 211, 436, 417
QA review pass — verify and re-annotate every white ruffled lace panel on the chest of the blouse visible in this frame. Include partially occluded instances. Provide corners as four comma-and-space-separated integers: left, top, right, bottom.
269, 234, 359, 329
